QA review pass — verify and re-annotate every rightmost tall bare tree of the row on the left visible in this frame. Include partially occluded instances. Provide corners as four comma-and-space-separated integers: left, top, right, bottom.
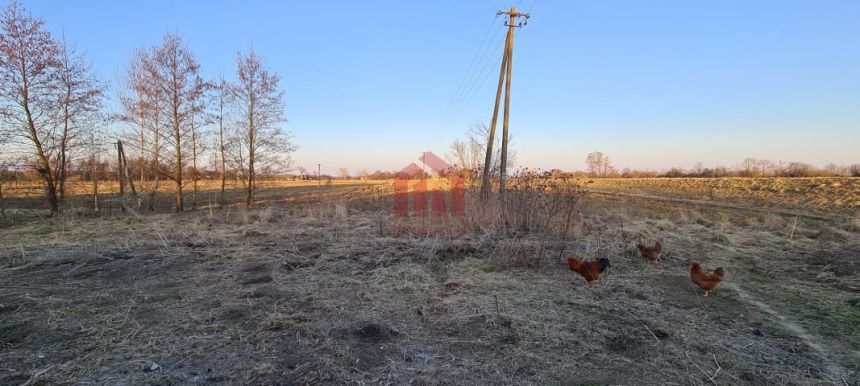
232, 48, 293, 207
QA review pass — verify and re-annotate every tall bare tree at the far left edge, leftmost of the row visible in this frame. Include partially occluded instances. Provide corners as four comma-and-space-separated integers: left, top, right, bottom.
0, 0, 62, 213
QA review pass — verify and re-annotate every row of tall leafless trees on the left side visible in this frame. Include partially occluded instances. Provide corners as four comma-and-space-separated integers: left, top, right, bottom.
0, 0, 295, 213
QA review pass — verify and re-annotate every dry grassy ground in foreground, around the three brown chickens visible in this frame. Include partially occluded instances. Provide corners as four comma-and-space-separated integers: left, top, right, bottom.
0, 179, 860, 385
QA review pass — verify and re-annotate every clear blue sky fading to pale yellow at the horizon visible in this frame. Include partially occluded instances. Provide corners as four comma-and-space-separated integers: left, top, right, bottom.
24, 0, 860, 174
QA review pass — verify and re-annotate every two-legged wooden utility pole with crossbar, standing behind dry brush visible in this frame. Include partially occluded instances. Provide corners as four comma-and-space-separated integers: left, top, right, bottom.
481, 7, 530, 200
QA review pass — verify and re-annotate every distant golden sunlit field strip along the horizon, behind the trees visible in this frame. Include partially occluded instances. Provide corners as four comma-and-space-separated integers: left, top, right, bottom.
3, 177, 860, 213
